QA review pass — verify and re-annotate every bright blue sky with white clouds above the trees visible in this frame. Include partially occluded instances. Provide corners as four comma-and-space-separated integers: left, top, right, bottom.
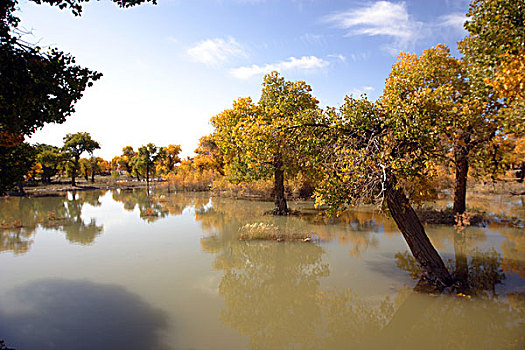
18, 0, 469, 160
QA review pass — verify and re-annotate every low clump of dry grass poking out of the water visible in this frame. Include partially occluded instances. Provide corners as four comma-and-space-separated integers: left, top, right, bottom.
239, 222, 312, 242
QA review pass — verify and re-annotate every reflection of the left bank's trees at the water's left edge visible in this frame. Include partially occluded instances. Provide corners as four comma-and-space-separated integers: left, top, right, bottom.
0, 191, 105, 254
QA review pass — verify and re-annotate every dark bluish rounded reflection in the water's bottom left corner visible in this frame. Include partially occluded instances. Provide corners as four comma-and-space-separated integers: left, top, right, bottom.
0, 280, 167, 350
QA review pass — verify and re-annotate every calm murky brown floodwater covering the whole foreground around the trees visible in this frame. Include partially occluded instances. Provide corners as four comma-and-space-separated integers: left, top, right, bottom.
0, 190, 525, 350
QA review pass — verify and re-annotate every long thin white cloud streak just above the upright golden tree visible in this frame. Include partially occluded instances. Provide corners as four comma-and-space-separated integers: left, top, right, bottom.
230, 56, 330, 79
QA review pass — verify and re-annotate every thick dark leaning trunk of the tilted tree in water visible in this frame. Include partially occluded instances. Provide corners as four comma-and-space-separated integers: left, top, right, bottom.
386, 180, 452, 286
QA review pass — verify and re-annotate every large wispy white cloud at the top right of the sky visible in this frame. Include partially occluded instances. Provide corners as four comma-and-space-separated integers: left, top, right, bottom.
325, 1, 423, 51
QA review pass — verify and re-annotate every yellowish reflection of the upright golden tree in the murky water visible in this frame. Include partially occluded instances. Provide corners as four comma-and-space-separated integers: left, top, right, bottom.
203, 239, 329, 349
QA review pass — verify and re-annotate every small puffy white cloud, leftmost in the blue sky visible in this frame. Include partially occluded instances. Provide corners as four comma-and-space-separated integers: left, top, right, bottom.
187, 37, 246, 66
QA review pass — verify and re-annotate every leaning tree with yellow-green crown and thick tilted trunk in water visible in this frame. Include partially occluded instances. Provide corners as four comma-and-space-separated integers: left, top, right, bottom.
316, 97, 452, 286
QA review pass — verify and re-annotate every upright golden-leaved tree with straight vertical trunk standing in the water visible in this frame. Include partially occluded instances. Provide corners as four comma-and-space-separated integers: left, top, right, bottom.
211, 72, 318, 215
